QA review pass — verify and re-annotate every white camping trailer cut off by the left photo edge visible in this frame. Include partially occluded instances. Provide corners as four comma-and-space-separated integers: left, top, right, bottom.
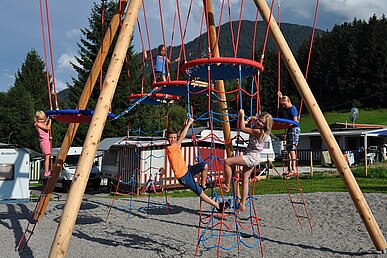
0, 144, 30, 203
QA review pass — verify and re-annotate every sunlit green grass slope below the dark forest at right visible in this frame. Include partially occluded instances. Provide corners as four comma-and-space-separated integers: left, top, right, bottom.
274, 109, 387, 133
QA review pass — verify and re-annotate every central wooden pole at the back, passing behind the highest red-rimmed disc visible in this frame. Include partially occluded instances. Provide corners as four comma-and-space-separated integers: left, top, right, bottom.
203, 0, 234, 157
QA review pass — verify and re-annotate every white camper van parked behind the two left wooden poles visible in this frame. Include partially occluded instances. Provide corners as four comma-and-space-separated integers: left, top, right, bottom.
52, 147, 101, 193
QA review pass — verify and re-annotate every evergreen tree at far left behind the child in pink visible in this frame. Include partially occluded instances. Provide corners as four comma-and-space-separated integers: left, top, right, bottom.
0, 50, 49, 151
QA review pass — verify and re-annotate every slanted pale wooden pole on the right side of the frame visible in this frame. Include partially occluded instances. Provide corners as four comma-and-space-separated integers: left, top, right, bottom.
254, 0, 387, 251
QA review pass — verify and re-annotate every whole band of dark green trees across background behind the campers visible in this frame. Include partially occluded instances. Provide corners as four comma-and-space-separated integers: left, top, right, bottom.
0, 1, 387, 151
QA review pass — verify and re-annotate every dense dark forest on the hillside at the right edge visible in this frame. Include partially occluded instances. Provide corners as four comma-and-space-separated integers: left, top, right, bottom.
299, 16, 387, 110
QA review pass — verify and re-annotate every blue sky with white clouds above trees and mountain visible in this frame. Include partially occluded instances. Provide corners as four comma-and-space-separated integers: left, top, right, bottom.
0, 0, 387, 92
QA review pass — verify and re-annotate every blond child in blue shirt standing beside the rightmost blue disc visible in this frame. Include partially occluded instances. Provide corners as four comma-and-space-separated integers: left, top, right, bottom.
281, 96, 301, 177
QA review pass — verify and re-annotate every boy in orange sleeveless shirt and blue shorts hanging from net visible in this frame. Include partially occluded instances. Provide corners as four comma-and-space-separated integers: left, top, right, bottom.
167, 118, 228, 213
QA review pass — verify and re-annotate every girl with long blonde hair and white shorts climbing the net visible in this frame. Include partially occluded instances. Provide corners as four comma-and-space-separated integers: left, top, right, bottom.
222, 109, 273, 211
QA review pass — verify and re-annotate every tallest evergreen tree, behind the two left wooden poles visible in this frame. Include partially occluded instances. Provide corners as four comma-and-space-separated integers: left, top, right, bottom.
67, 1, 149, 145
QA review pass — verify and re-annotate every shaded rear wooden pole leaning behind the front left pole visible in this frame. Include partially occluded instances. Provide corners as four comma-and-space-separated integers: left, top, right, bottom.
34, 0, 128, 221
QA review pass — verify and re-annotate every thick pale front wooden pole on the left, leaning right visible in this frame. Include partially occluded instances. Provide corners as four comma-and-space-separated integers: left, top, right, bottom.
49, 0, 141, 257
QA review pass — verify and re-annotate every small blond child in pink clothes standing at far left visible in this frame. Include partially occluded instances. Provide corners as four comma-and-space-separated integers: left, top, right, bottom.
34, 110, 51, 177
